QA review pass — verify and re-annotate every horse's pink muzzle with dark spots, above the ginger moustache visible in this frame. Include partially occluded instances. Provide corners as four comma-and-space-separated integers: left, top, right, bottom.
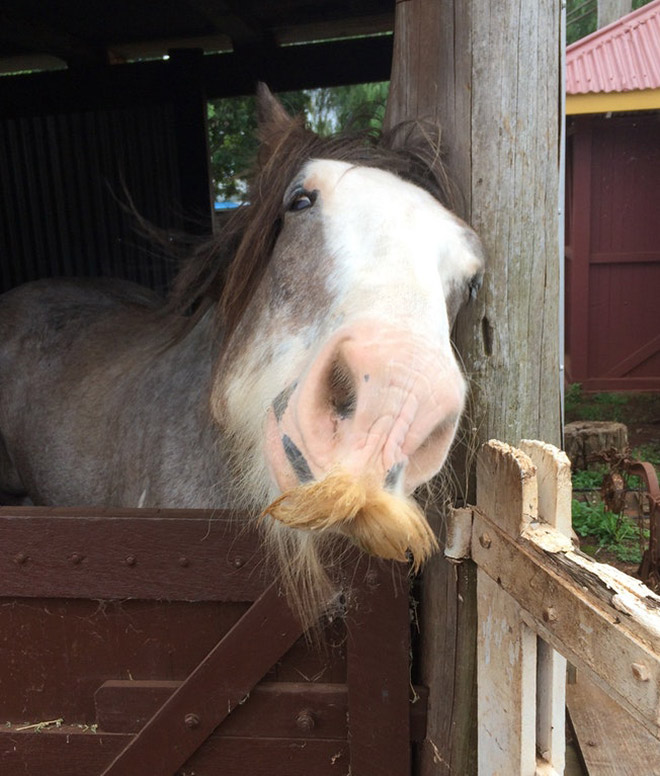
266, 324, 465, 493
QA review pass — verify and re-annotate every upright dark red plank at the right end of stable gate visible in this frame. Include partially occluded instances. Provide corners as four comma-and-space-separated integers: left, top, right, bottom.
346, 558, 411, 776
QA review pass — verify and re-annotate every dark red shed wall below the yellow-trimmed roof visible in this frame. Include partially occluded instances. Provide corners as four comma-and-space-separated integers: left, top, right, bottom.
566, 112, 660, 391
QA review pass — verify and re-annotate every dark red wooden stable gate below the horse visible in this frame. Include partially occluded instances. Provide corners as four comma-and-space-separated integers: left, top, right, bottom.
0, 508, 426, 776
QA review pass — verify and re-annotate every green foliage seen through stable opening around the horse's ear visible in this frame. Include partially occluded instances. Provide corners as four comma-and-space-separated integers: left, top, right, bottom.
207, 82, 388, 202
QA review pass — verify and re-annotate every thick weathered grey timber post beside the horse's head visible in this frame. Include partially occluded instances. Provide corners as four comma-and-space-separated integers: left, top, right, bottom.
386, 0, 560, 776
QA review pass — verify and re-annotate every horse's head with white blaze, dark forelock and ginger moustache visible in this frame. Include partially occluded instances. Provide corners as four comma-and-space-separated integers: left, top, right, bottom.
201, 87, 483, 620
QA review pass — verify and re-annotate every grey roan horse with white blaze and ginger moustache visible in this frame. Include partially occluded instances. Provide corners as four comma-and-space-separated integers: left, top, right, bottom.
0, 85, 484, 620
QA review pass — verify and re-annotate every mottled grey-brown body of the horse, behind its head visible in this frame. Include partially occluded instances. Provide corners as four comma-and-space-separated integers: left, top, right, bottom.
0, 280, 229, 508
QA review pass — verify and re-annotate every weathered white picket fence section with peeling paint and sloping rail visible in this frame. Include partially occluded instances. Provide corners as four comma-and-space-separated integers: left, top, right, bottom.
449, 441, 660, 776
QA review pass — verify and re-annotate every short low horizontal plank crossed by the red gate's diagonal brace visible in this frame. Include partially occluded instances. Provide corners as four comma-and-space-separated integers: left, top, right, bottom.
95, 680, 428, 741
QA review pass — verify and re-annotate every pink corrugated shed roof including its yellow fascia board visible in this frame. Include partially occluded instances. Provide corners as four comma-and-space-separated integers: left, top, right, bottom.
566, 0, 660, 114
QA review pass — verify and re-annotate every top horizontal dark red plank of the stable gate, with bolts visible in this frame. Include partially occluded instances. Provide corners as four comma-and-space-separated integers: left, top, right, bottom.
0, 507, 267, 601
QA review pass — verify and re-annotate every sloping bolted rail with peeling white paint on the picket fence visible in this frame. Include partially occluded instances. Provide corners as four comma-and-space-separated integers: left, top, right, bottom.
472, 510, 660, 734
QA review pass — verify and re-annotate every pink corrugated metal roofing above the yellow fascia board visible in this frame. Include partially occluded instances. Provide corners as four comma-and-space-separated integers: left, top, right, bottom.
566, 0, 660, 95
